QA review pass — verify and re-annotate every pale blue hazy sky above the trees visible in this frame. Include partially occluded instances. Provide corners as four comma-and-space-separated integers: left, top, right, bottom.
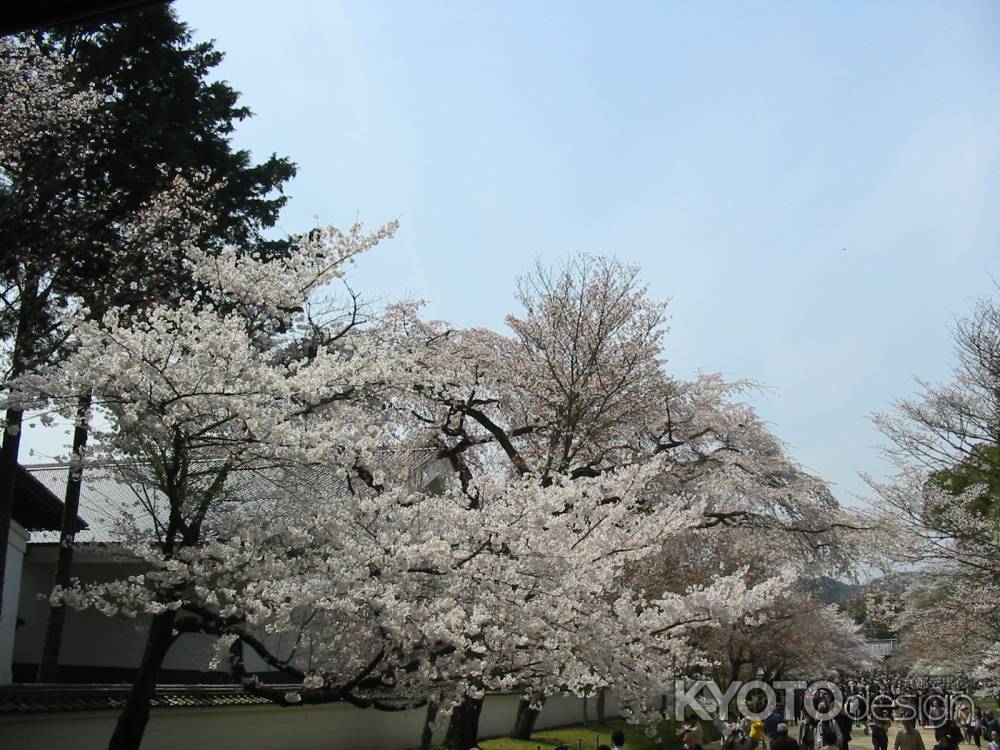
21, 0, 1000, 508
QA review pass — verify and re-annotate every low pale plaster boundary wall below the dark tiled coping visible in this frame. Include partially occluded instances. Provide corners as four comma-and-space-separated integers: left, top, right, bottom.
0, 695, 617, 750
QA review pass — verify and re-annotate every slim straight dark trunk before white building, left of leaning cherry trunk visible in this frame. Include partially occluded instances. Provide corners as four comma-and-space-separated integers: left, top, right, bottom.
38, 393, 91, 682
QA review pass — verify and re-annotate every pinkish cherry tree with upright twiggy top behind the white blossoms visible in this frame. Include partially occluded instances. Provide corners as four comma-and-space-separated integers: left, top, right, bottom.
398, 256, 860, 739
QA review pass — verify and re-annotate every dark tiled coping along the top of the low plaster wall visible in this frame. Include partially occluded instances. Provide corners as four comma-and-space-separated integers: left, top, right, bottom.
0, 685, 278, 715
